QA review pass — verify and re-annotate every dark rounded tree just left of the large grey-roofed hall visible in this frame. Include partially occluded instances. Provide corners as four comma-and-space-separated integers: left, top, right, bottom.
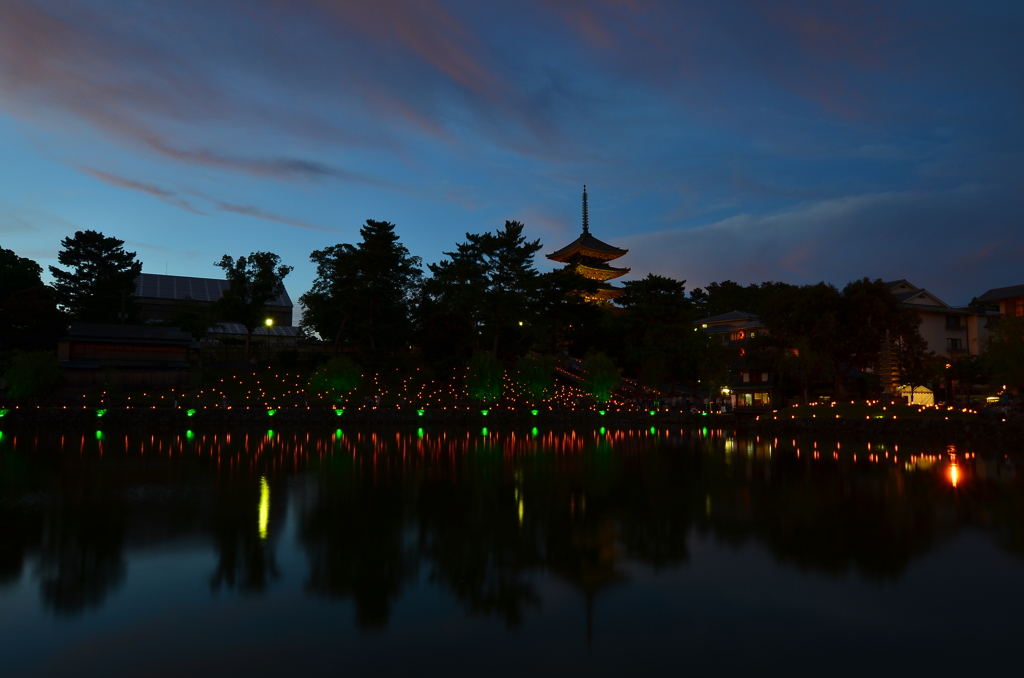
50, 230, 142, 324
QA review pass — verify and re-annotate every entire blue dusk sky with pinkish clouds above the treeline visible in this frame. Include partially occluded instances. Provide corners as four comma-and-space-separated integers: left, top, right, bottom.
0, 0, 1024, 317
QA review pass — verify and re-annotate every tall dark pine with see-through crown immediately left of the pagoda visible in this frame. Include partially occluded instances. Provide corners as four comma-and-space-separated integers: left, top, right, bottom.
424, 221, 542, 357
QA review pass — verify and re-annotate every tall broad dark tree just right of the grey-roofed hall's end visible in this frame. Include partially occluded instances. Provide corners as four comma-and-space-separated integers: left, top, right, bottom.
299, 219, 423, 354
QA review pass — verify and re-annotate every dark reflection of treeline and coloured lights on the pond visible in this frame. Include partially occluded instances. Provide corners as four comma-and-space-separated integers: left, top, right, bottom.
0, 428, 1024, 634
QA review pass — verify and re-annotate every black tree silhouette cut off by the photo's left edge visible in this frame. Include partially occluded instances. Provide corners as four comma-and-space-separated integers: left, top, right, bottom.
0, 248, 68, 349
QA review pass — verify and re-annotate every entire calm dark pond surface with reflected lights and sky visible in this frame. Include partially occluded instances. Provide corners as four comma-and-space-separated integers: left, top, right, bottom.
0, 429, 1024, 678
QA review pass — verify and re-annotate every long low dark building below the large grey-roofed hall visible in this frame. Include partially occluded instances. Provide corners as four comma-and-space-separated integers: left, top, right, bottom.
57, 323, 199, 388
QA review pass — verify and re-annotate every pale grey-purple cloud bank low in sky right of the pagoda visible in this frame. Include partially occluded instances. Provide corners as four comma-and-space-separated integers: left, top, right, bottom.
623, 185, 1024, 303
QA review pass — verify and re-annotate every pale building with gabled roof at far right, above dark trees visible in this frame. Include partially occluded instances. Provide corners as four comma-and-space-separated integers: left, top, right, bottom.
886, 280, 989, 358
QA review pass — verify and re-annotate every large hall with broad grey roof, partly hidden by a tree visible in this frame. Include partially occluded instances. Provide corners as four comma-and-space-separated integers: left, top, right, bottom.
135, 273, 293, 335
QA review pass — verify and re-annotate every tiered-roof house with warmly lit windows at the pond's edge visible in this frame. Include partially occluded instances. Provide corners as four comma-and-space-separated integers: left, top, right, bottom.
693, 310, 779, 412
